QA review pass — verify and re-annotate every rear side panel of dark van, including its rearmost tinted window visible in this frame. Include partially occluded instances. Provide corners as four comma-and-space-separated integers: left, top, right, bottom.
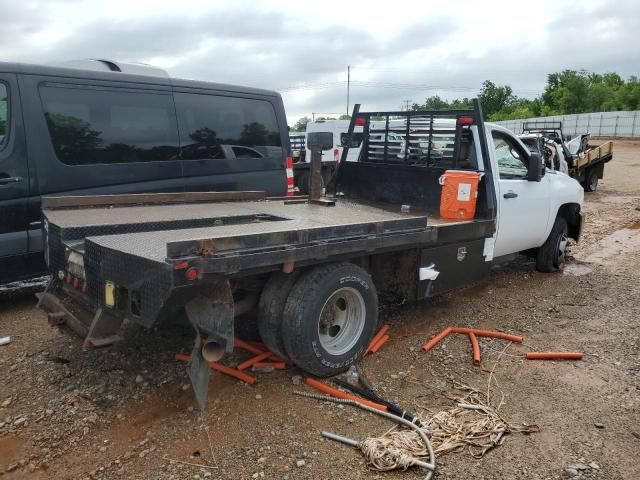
174, 87, 288, 195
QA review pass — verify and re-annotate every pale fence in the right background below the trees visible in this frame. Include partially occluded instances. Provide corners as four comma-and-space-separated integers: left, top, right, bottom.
494, 110, 640, 137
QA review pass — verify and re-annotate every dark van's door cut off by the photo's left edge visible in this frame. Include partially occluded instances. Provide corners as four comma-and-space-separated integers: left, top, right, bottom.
0, 73, 29, 274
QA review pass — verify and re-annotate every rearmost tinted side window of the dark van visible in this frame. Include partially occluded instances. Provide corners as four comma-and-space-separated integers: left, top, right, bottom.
175, 93, 282, 160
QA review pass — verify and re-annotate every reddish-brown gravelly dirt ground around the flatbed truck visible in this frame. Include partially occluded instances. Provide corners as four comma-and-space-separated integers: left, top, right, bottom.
0, 141, 640, 480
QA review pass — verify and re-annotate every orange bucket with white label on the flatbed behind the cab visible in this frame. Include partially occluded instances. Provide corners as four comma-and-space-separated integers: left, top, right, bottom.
440, 170, 483, 220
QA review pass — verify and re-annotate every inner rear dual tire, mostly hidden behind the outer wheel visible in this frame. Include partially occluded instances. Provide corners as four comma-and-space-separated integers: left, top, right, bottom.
258, 270, 301, 360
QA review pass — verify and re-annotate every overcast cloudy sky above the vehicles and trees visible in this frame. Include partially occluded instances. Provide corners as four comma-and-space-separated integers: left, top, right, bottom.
0, 0, 640, 124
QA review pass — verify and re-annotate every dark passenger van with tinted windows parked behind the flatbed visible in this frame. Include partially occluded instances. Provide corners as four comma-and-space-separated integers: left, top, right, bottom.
0, 61, 289, 284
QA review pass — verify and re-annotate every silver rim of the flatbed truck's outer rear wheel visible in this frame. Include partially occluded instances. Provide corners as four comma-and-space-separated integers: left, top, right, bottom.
318, 287, 366, 355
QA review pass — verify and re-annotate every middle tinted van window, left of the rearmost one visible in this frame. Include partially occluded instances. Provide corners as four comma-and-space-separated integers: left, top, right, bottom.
40, 86, 179, 165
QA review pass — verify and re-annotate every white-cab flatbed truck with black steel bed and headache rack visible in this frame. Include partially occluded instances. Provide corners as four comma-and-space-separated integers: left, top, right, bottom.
39, 101, 582, 408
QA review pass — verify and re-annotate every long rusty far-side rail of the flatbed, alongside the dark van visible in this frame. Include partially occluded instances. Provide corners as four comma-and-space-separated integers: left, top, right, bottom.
42, 191, 265, 210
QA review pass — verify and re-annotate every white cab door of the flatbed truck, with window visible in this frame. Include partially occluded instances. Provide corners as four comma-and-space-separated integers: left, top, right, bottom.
489, 126, 551, 257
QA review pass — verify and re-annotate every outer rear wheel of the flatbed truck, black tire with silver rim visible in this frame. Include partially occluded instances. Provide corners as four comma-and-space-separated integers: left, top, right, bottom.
282, 263, 378, 377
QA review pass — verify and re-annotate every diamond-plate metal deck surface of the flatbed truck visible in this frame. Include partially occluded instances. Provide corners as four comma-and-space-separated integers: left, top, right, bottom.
46, 200, 488, 262
